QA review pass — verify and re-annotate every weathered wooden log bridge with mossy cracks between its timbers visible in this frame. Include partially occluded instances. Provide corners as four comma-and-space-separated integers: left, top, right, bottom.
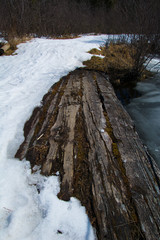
16, 69, 160, 240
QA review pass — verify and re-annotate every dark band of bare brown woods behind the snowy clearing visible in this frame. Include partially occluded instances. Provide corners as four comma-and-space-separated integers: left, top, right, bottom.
0, 0, 160, 36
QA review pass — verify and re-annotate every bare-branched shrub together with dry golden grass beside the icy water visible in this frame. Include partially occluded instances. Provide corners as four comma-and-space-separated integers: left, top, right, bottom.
84, 34, 159, 84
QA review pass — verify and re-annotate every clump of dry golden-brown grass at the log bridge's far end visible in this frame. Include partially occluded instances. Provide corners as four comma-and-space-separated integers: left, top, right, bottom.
83, 42, 148, 84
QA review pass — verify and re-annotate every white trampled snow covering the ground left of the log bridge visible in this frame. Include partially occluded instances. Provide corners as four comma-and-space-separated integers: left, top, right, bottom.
0, 35, 107, 240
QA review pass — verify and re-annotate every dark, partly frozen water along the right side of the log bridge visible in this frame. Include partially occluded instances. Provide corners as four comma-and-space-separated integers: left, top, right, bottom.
116, 59, 160, 168
